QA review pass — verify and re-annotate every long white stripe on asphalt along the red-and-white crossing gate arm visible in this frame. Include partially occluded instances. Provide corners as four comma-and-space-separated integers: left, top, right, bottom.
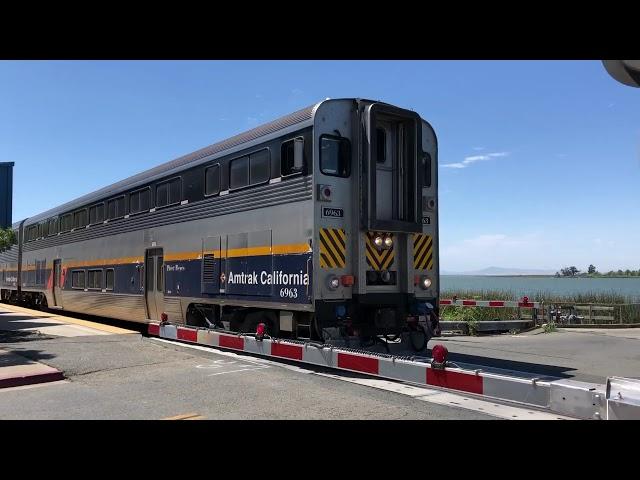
154, 338, 574, 420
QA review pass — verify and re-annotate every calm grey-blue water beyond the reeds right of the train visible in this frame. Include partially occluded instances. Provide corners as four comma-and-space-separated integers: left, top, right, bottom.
440, 275, 640, 302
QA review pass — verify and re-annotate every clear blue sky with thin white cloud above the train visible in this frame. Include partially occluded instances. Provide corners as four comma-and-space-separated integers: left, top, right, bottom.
0, 61, 640, 271
